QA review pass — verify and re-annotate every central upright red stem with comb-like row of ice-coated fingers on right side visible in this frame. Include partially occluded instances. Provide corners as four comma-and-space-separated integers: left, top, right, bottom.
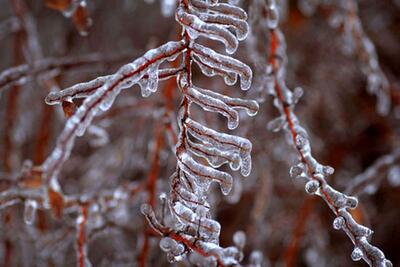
143, 0, 258, 266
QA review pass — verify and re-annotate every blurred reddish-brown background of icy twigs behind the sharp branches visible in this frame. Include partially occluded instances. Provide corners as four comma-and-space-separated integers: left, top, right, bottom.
0, 0, 400, 267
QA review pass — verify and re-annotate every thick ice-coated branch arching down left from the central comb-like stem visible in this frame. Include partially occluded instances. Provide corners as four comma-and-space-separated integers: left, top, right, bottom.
42, 41, 187, 193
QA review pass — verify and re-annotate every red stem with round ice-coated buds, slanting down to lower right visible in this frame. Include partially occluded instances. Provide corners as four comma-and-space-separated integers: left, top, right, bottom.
266, 0, 392, 267
